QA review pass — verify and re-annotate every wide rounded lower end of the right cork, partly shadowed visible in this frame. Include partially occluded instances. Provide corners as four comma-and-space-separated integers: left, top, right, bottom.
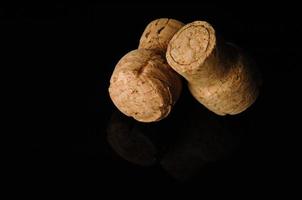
188, 45, 259, 115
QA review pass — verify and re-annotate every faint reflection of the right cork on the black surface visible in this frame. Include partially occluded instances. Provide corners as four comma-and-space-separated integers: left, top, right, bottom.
161, 109, 237, 180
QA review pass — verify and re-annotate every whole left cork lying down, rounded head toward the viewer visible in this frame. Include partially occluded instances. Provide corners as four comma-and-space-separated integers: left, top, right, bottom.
109, 18, 183, 122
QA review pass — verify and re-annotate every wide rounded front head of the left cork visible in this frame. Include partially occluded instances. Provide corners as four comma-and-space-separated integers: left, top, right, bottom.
109, 49, 181, 122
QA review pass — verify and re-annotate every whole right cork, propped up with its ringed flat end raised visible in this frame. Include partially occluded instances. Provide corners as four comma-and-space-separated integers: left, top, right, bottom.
166, 21, 259, 115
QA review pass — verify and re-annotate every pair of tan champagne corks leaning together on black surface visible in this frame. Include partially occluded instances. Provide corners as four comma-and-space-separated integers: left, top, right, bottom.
109, 18, 259, 122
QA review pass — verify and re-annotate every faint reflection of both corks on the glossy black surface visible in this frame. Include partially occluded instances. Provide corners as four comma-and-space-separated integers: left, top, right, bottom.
107, 95, 247, 180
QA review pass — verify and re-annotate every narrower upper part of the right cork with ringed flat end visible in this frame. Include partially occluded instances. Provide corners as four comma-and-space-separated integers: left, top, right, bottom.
166, 21, 225, 85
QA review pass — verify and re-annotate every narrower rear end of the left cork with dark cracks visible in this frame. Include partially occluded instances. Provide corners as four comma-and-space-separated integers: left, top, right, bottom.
138, 18, 184, 54
